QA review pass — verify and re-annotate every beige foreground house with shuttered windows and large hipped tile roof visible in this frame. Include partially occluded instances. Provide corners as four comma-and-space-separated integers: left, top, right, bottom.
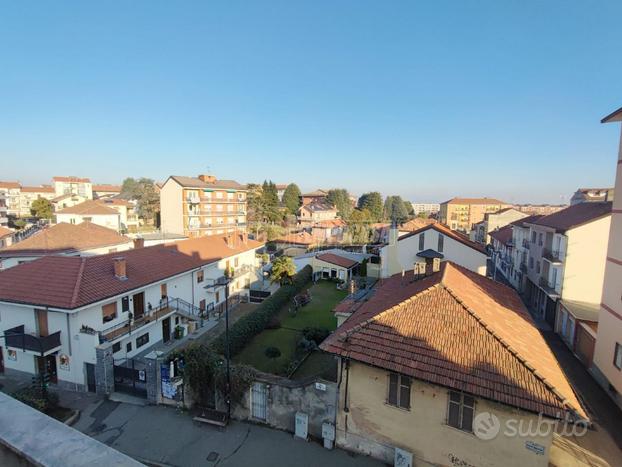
320, 262, 587, 467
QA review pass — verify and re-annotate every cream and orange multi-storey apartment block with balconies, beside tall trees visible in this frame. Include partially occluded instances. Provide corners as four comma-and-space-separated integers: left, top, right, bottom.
160, 175, 247, 237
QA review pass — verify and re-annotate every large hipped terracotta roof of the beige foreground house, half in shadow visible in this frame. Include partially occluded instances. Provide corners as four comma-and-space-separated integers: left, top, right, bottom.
320, 262, 587, 418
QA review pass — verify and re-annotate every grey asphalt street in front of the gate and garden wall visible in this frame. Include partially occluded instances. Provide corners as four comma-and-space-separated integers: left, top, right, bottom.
74, 401, 382, 467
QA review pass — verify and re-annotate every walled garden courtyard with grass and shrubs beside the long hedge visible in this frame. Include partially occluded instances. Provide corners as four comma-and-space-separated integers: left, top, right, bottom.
234, 281, 347, 379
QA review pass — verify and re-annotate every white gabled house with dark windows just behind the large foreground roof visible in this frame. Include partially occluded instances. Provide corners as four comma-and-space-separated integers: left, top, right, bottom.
367, 223, 487, 277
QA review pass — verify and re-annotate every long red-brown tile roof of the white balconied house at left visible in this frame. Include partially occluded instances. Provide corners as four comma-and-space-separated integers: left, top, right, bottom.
0, 235, 263, 309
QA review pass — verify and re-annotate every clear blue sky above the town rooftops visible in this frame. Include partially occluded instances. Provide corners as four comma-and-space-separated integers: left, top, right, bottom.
0, 0, 622, 202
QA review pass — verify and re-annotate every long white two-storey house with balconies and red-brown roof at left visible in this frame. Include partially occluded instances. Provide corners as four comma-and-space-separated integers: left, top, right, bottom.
0, 234, 262, 393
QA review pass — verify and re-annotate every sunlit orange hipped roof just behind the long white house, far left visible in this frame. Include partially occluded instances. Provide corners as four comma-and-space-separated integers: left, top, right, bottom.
0, 222, 132, 258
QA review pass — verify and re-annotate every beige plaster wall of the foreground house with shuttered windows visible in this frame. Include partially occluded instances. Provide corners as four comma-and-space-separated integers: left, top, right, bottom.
336, 362, 552, 467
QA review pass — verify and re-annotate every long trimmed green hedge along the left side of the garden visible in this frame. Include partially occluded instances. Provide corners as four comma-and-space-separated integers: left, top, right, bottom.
212, 266, 313, 356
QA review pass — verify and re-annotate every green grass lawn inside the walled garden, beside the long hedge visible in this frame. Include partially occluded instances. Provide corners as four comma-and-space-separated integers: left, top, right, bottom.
234, 282, 347, 374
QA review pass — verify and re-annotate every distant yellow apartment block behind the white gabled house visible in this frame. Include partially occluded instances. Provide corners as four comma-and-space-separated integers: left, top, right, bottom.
439, 198, 511, 234
